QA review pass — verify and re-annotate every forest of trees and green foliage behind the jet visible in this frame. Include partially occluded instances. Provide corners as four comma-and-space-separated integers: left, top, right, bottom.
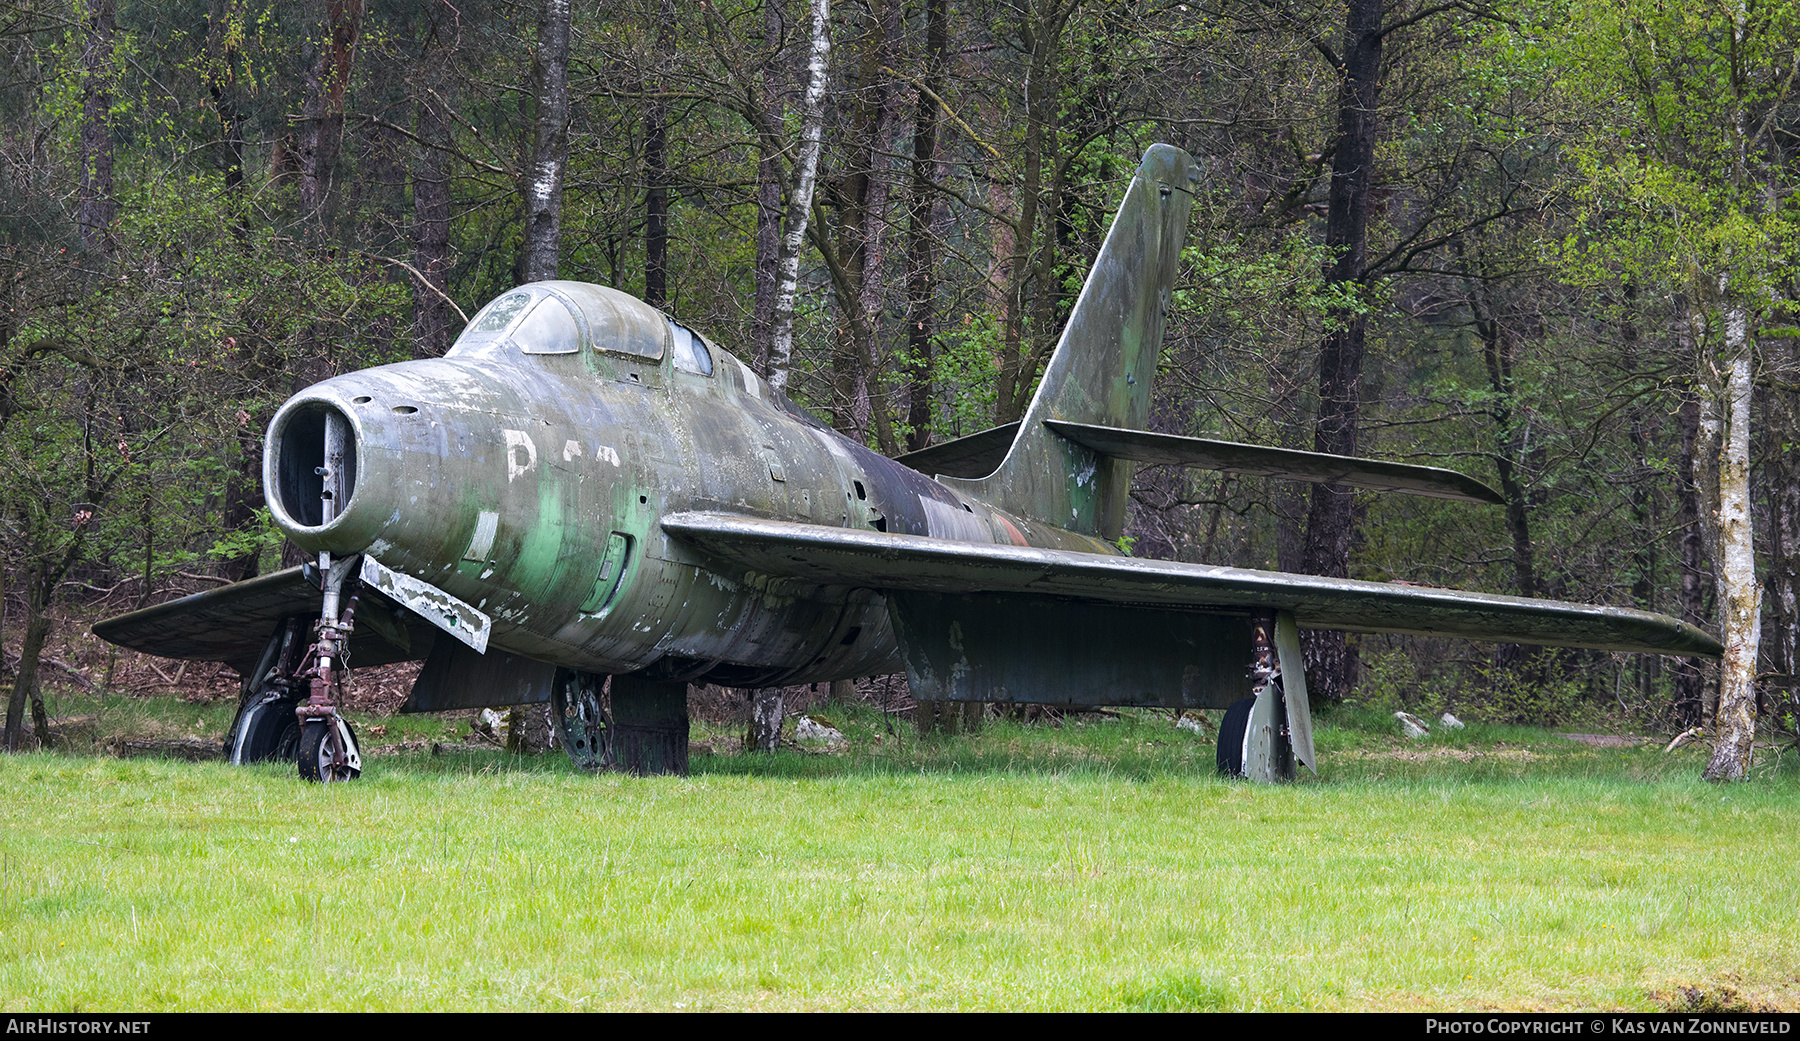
0, 0, 1800, 776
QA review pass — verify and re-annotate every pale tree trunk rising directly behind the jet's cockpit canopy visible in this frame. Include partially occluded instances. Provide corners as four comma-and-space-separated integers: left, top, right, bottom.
518, 0, 571, 283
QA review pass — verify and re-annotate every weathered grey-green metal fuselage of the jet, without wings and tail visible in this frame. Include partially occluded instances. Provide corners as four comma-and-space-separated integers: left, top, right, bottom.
265, 283, 1114, 686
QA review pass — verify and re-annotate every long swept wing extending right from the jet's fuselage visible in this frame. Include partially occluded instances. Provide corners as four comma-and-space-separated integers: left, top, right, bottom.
662, 513, 1723, 657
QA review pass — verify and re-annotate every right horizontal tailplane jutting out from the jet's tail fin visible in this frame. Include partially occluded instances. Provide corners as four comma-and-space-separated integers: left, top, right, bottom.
1044, 420, 1507, 504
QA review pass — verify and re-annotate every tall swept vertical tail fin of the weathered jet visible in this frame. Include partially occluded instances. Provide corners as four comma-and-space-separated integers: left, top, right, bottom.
940, 144, 1199, 539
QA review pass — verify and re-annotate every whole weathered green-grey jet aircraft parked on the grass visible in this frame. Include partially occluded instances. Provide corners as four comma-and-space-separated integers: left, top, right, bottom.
95, 146, 1721, 780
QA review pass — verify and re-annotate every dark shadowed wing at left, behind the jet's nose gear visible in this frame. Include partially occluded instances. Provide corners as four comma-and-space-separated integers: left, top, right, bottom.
94, 567, 437, 672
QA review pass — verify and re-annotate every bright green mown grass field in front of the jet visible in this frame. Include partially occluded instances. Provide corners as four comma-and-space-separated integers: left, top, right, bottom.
0, 691, 1800, 1010
